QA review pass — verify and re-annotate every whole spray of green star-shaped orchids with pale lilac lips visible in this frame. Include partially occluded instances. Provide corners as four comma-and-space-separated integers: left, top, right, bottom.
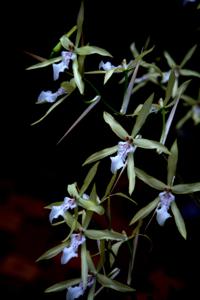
28, 3, 200, 300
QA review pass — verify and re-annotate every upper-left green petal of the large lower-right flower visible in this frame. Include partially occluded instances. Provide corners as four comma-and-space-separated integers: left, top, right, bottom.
135, 167, 167, 191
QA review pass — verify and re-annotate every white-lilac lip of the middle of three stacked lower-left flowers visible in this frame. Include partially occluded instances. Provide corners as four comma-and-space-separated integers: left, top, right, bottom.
61, 233, 85, 265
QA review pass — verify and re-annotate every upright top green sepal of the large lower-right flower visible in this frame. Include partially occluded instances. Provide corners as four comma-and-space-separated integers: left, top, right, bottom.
167, 140, 178, 186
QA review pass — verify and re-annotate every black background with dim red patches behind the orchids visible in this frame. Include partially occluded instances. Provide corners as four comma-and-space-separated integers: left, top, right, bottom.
0, 0, 200, 300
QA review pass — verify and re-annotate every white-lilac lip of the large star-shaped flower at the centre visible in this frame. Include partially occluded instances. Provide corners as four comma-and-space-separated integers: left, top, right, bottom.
110, 141, 136, 173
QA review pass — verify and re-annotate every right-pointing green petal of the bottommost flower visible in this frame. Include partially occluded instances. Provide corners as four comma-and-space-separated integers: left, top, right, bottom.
96, 274, 135, 292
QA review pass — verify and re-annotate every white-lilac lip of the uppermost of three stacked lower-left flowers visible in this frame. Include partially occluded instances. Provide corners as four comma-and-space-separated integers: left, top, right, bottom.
49, 197, 77, 223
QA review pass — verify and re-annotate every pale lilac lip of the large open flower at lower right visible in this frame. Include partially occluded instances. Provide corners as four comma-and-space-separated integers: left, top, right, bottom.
156, 191, 175, 226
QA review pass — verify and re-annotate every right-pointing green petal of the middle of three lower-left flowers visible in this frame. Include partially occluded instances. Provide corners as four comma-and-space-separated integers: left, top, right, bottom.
84, 229, 127, 241
